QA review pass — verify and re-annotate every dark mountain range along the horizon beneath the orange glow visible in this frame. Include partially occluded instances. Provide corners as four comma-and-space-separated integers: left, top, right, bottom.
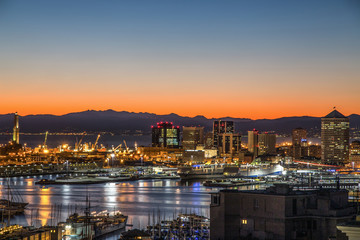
0, 110, 360, 135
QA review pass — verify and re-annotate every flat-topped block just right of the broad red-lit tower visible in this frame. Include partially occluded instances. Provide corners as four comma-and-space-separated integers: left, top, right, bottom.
182, 127, 204, 150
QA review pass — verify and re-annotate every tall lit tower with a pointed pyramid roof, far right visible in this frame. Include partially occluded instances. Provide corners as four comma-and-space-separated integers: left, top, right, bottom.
321, 110, 350, 165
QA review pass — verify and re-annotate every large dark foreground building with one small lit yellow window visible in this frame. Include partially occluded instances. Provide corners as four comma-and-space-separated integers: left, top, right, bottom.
210, 184, 355, 240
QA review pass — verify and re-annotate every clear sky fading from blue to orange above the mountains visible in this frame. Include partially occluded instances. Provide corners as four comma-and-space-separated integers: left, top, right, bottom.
0, 0, 360, 119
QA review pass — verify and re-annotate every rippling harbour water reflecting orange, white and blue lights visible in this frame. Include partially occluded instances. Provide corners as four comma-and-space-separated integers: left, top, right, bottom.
0, 176, 264, 239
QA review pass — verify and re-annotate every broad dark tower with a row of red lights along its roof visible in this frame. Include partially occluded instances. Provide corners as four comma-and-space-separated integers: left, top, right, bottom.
151, 122, 180, 148
